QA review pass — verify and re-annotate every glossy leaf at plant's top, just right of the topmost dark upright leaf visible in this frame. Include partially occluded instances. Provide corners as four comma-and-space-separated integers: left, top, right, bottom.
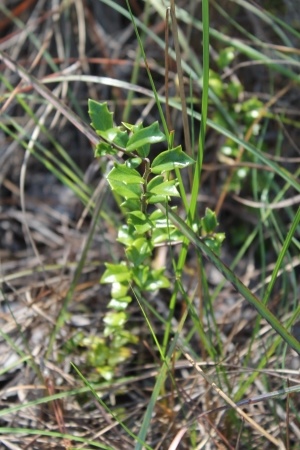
126, 122, 166, 158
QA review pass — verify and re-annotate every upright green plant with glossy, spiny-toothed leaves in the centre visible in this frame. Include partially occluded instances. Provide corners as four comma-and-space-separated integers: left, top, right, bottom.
89, 100, 224, 379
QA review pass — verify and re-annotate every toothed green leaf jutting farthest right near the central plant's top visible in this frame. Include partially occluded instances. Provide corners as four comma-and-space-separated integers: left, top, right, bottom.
151, 145, 195, 174
